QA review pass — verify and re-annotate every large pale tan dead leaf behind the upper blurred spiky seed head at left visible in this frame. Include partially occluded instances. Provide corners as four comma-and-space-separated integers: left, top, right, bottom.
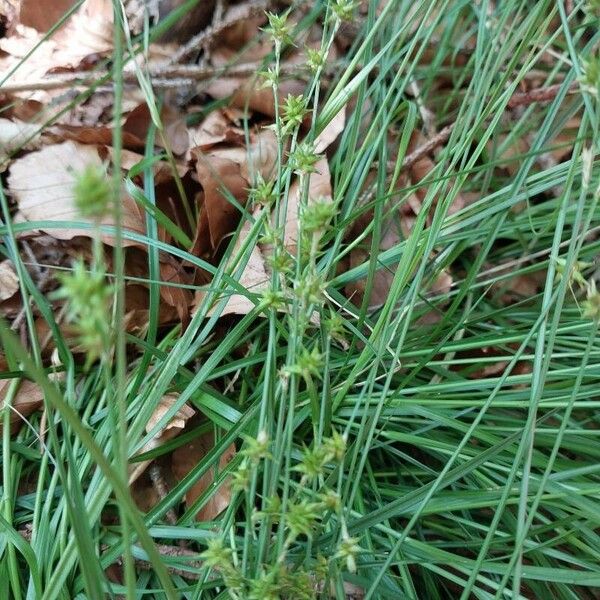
8, 141, 146, 245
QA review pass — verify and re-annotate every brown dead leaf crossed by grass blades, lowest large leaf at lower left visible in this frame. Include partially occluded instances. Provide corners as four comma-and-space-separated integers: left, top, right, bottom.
171, 432, 235, 521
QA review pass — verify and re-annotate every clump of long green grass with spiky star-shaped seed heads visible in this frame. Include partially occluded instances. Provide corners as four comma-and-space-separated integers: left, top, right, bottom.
0, 0, 600, 600
